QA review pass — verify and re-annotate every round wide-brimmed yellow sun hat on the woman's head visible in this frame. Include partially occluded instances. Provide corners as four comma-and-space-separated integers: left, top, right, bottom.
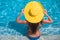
24, 1, 44, 23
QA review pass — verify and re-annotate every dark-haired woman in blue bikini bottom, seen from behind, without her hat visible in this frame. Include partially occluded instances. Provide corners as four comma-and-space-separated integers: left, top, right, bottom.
16, 10, 53, 40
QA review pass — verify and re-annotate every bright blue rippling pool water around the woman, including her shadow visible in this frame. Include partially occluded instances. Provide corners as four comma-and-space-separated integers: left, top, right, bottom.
0, 0, 60, 39
